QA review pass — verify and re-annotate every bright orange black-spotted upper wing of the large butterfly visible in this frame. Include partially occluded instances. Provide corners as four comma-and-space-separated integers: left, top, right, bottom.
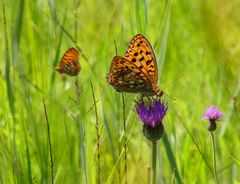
124, 34, 158, 86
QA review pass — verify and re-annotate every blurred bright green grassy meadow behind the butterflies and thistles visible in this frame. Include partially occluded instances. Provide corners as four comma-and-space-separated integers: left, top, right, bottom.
0, 0, 240, 184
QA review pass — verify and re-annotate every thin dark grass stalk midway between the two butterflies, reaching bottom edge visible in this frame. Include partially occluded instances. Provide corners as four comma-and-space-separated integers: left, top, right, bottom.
91, 82, 101, 184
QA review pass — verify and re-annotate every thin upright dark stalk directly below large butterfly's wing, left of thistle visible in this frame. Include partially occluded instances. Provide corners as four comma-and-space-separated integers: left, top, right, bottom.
122, 93, 127, 184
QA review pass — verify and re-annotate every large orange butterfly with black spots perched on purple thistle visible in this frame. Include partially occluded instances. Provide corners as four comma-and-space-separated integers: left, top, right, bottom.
106, 34, 164, 96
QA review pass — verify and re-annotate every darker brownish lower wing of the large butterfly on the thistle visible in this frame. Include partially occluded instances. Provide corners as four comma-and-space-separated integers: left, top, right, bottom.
107, 56, 153, 94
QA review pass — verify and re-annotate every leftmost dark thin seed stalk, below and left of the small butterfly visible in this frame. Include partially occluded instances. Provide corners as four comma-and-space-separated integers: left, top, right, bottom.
43, 98, 54, 184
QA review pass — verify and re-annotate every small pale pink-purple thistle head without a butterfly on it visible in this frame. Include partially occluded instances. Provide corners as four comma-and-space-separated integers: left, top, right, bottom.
203, 105, 223, 132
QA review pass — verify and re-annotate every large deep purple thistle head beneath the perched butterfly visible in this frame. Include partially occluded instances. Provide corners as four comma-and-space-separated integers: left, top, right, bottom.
135, 99, 168, 142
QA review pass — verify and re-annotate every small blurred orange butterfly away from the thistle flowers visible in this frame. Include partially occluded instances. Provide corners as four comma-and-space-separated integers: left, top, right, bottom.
55, 47, 81, 76
